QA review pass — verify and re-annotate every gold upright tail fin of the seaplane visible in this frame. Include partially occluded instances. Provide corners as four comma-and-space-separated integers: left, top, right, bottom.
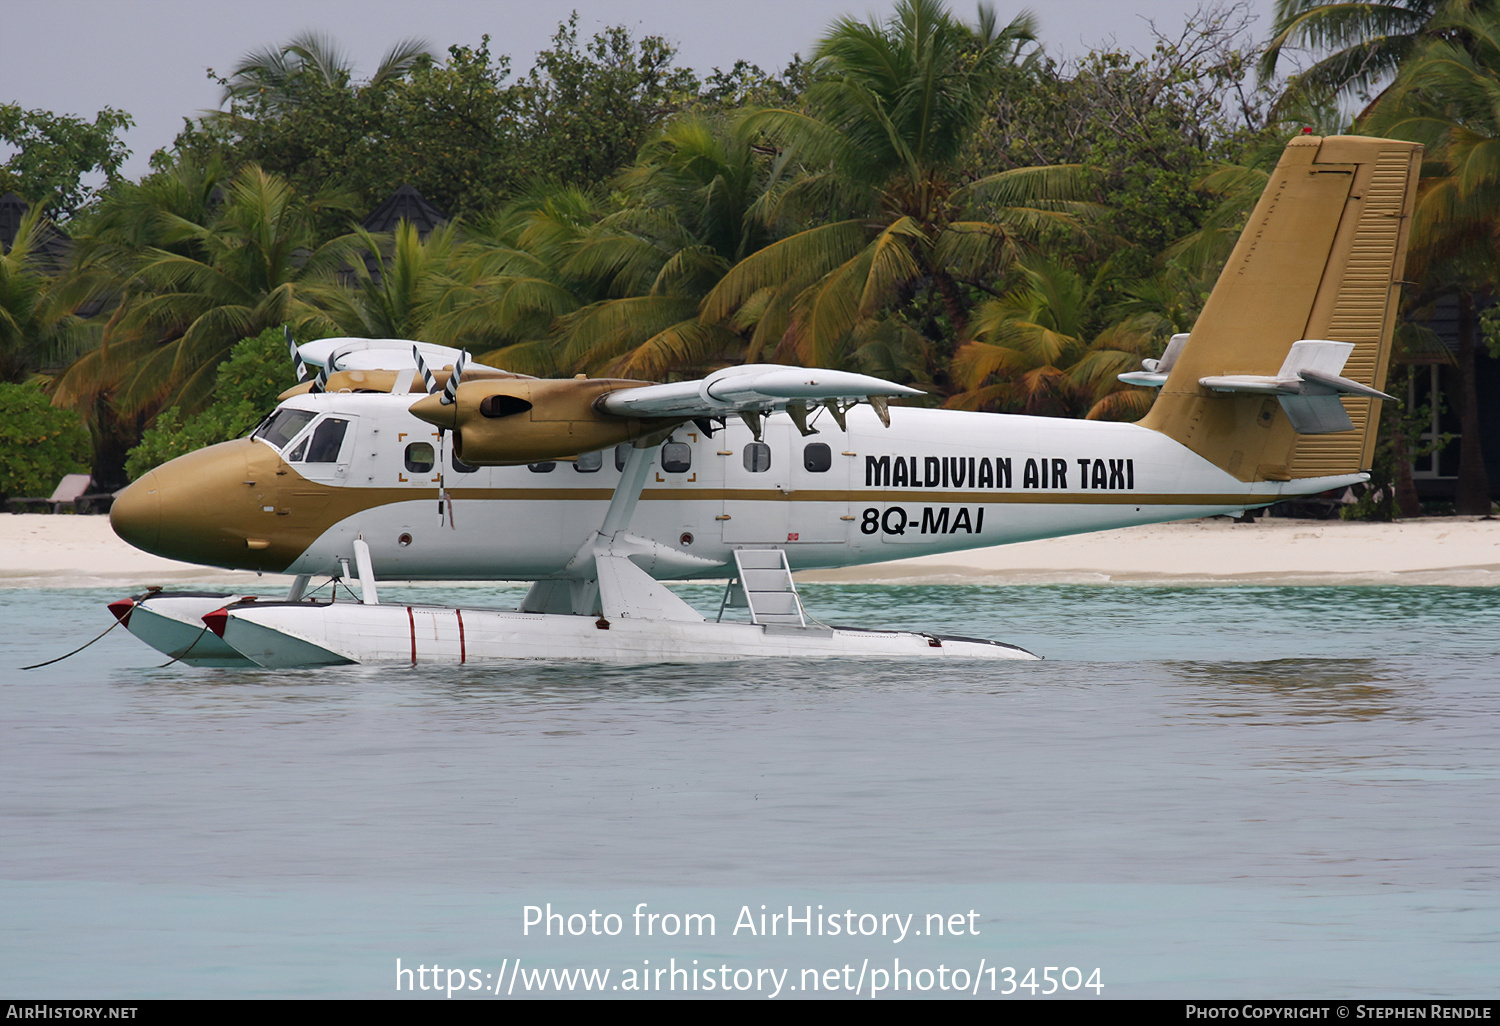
1140, 135, 1422, 482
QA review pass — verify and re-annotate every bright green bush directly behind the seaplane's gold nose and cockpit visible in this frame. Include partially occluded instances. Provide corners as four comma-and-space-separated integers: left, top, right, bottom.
125, 327, 297, 482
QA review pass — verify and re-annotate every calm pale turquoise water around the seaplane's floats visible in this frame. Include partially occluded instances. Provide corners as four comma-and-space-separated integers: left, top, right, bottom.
0, 585, 1500, 999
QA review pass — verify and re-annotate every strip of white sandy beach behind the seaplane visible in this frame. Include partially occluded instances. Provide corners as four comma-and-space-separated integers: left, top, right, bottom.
0, 515, 1500, 591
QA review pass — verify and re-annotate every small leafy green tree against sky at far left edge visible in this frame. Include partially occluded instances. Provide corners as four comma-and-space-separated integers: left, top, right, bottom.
0, 104, 135, 221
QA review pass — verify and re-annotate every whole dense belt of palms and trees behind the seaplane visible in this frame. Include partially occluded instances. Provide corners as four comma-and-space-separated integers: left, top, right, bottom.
0, 0, 1500, 510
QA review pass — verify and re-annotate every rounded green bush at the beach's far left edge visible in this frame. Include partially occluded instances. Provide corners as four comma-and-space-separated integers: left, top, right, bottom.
0, 384, 89, 498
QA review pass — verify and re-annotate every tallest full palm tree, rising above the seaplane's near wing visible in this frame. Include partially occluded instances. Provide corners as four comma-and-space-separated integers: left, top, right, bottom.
702, 0, 1079, 381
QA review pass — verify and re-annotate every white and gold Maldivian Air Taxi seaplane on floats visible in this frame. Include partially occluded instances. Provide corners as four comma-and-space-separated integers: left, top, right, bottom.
110, 135, 1421, 669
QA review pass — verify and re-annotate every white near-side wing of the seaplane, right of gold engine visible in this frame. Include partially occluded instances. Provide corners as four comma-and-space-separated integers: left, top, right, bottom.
599, 363, 923, 417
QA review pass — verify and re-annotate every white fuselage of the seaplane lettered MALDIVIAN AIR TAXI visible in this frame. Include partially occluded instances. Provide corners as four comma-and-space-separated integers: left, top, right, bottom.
260, 395, 1364, 581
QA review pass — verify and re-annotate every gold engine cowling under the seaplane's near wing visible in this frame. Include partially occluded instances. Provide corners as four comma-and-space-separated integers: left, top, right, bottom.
411, 378, 672, 467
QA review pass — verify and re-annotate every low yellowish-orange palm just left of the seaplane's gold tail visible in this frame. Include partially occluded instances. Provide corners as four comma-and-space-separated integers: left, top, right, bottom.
947, 258, 1157, 420
